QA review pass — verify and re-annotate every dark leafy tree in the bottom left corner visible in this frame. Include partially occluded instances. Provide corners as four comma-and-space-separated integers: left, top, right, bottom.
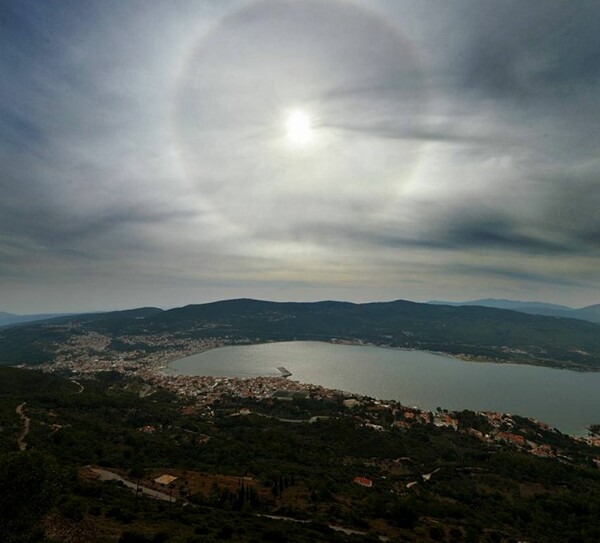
0, 451, 61, 543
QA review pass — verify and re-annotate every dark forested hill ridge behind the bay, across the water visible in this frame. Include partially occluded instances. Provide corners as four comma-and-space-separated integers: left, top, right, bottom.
0, 299, 600, 370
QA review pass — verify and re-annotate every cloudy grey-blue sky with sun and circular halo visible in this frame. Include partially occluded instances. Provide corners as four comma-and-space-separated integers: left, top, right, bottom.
0, 0, 600, 313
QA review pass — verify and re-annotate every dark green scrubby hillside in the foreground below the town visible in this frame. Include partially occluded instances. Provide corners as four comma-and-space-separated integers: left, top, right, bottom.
0, 368, 600, 543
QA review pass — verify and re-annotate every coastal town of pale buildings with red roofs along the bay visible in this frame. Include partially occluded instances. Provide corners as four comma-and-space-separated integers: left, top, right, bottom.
28, 332, 600, 466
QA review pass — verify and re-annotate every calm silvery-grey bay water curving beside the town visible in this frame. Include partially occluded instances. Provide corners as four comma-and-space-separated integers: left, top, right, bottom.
167, 341, 600, 435
